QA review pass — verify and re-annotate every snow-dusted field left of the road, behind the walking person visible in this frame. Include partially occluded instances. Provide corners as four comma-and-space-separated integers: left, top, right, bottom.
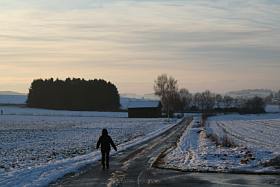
0, 108, 177, 186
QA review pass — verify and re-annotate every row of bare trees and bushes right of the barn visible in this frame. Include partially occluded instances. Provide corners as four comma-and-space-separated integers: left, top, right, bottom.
154, 74, 270, 116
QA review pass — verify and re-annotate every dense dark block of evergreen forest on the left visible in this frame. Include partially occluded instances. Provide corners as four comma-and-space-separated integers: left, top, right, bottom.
27, 78, 120, 111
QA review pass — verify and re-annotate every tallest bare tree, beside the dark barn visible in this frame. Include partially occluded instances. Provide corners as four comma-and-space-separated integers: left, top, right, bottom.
154, 74, 178, 117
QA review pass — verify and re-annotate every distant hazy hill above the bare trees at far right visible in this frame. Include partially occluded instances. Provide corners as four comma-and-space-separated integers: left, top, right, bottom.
225, 89, 274, 98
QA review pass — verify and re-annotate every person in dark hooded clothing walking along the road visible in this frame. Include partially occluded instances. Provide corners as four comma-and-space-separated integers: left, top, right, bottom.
96, 129, 117, 169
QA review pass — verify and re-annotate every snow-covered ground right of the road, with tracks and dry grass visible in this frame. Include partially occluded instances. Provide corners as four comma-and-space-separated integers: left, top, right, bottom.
162, 114, 280, 173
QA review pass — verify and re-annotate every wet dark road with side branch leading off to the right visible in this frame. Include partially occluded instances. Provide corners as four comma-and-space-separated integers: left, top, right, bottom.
50, 118, 280, 187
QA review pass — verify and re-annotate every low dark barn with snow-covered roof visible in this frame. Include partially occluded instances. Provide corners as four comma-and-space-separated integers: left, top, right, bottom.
128, 101, 162, 118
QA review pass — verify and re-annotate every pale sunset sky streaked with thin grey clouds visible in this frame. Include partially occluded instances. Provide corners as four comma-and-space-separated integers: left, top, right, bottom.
0, 0, 280, 94
